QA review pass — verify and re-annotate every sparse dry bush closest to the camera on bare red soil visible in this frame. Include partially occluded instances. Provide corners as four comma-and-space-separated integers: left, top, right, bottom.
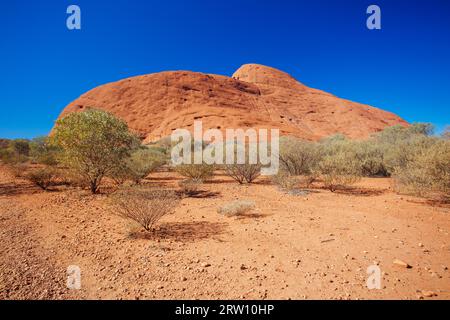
111, 187, 179, 231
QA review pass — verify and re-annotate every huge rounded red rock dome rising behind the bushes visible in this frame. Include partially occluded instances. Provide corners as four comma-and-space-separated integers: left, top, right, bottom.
56, 64, 408, 142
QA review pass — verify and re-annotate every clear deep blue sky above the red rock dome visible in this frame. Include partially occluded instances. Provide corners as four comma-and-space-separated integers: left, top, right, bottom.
0, 0, 450, 138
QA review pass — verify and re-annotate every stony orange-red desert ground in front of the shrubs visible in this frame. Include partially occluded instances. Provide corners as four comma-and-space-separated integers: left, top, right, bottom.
0, 167, 450, 299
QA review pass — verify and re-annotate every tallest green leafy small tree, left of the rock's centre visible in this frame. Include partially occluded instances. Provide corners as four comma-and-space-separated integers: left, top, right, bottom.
52, 109, 139, 194
